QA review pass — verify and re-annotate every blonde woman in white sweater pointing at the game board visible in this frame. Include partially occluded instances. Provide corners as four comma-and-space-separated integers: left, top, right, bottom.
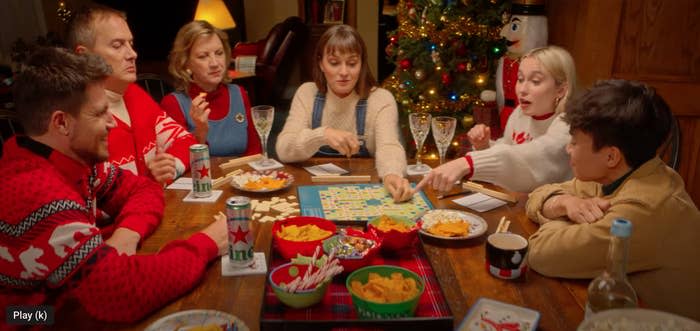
416, 46, 576, 192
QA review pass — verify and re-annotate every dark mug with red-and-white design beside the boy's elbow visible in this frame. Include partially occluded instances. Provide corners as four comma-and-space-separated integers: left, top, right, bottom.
486, 232, 528, 279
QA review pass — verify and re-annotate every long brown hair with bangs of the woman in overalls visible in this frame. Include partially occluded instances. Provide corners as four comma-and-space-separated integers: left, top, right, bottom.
313, 24, 377, 99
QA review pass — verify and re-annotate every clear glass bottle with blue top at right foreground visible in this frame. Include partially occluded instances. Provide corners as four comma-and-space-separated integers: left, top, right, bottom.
586, 219, 637, 318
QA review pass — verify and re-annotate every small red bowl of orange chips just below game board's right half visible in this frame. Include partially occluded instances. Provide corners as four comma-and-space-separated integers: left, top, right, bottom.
367, 215, 420, 251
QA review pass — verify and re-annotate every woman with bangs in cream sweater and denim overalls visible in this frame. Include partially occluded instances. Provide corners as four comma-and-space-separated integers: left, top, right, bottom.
275, 25, 412, 202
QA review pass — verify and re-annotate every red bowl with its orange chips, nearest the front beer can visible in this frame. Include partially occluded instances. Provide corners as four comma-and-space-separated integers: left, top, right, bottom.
272, 216, 336, 259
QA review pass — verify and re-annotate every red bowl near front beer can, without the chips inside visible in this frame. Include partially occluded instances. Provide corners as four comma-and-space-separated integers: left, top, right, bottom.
272, 216, 336, 259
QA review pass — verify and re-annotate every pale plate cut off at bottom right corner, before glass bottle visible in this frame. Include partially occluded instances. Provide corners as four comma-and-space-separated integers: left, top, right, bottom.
577, 308, 700, 331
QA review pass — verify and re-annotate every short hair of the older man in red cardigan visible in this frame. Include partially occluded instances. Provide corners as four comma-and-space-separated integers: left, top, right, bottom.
66, 4, 126, 51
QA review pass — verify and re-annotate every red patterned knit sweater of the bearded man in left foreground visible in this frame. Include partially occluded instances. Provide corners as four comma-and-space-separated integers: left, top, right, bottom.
0, 137, 217, 322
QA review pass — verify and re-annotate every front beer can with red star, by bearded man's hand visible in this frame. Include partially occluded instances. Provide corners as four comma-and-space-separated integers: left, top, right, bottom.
226, 196, 254, 267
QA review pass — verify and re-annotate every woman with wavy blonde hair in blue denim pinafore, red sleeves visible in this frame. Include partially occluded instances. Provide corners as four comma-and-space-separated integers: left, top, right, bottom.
161, 21, 262, 156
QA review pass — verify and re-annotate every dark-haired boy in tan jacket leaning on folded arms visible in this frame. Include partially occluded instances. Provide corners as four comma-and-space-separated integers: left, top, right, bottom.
526, 80, 700, 319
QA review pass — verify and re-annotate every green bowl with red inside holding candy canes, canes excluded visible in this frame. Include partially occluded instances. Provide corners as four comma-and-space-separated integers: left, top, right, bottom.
268, 263, 330, 308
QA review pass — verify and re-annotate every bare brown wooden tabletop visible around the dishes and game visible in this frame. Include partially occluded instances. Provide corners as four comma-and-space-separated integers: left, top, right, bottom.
52, 158, 588, 331
